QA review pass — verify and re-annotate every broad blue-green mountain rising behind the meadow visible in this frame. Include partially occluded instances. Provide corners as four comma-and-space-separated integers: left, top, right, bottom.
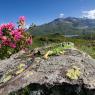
28, 17, 95, 38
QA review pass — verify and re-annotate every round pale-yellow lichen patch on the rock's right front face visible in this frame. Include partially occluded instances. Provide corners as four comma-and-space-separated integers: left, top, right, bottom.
66, 66, 81, 80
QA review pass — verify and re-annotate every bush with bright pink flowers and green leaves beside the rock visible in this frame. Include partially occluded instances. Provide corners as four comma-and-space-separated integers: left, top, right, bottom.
0, 16, 32, 59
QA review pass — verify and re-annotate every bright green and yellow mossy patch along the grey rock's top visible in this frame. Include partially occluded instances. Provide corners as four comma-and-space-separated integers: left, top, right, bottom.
43, 42, 74, 59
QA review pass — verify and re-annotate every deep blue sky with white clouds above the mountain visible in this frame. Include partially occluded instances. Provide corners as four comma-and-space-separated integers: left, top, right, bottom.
0, 0, 95, 26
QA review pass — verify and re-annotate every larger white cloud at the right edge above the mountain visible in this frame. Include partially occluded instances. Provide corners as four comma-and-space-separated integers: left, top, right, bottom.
82, 9, 95, 19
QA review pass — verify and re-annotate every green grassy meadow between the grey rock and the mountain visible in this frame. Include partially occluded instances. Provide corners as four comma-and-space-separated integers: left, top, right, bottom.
32, 34, 95, 58
